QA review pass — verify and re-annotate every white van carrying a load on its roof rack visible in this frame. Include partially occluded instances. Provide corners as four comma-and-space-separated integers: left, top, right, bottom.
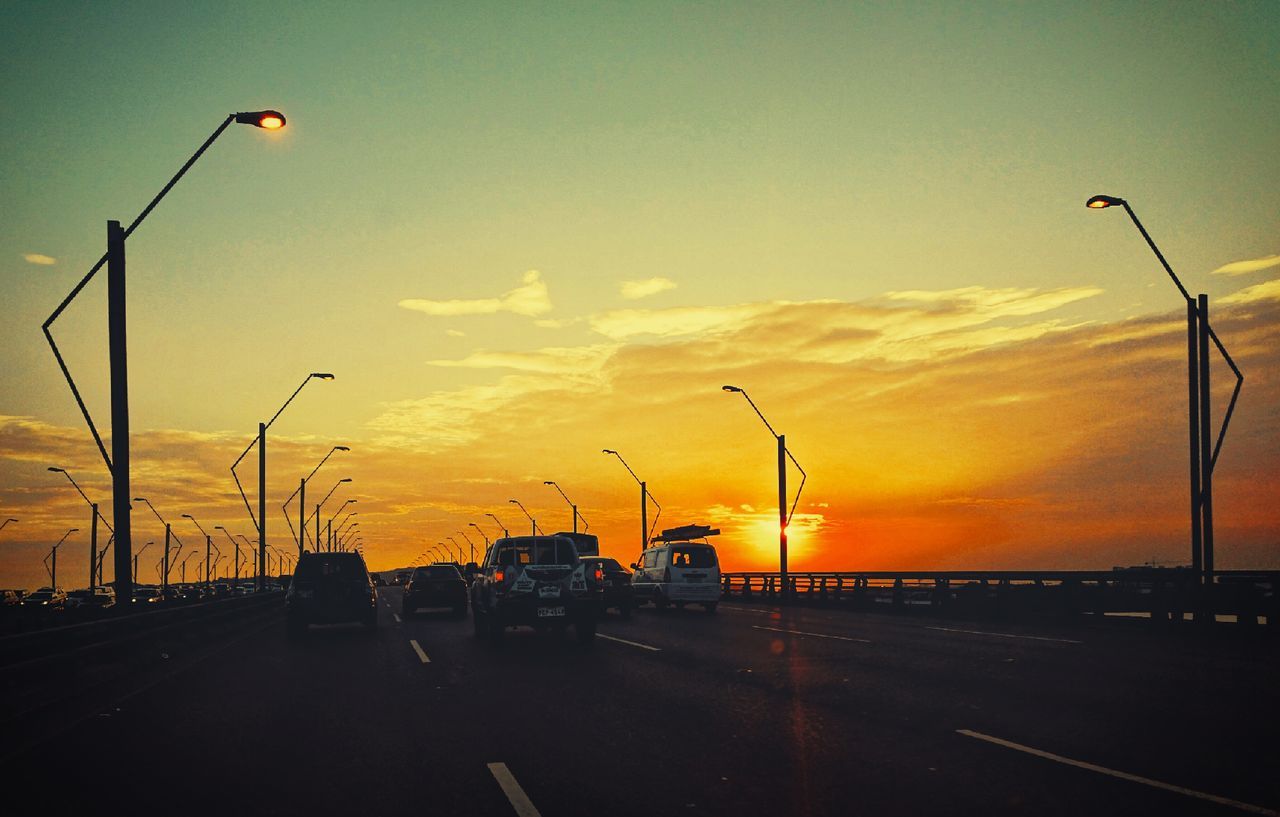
631, 525, 721, 613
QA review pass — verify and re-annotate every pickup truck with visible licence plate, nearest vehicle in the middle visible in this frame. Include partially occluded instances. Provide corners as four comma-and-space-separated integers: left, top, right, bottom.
471, 535, 604, 644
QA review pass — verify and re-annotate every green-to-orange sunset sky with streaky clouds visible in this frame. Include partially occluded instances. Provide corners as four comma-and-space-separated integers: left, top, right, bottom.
0, 0, 1280, 588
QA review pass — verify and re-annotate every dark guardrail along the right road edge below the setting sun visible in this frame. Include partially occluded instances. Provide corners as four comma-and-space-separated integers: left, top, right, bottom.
721, 567, 1280, 629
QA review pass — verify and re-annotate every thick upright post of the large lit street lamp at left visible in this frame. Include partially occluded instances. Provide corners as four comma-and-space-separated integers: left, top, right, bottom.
106, 222, 133, 599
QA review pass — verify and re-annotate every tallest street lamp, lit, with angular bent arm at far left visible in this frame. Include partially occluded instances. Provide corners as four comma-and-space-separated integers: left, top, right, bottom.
41, 110, 284, 609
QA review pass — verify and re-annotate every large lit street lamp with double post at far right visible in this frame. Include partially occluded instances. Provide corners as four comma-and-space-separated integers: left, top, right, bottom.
1084, 196, 1244, 599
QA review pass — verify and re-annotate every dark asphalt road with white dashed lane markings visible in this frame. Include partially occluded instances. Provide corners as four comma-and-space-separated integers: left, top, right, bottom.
0, 588, 1280, 817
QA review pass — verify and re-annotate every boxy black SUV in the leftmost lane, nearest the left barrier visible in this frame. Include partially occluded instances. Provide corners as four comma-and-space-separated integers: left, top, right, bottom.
284, 552, 378, 635
